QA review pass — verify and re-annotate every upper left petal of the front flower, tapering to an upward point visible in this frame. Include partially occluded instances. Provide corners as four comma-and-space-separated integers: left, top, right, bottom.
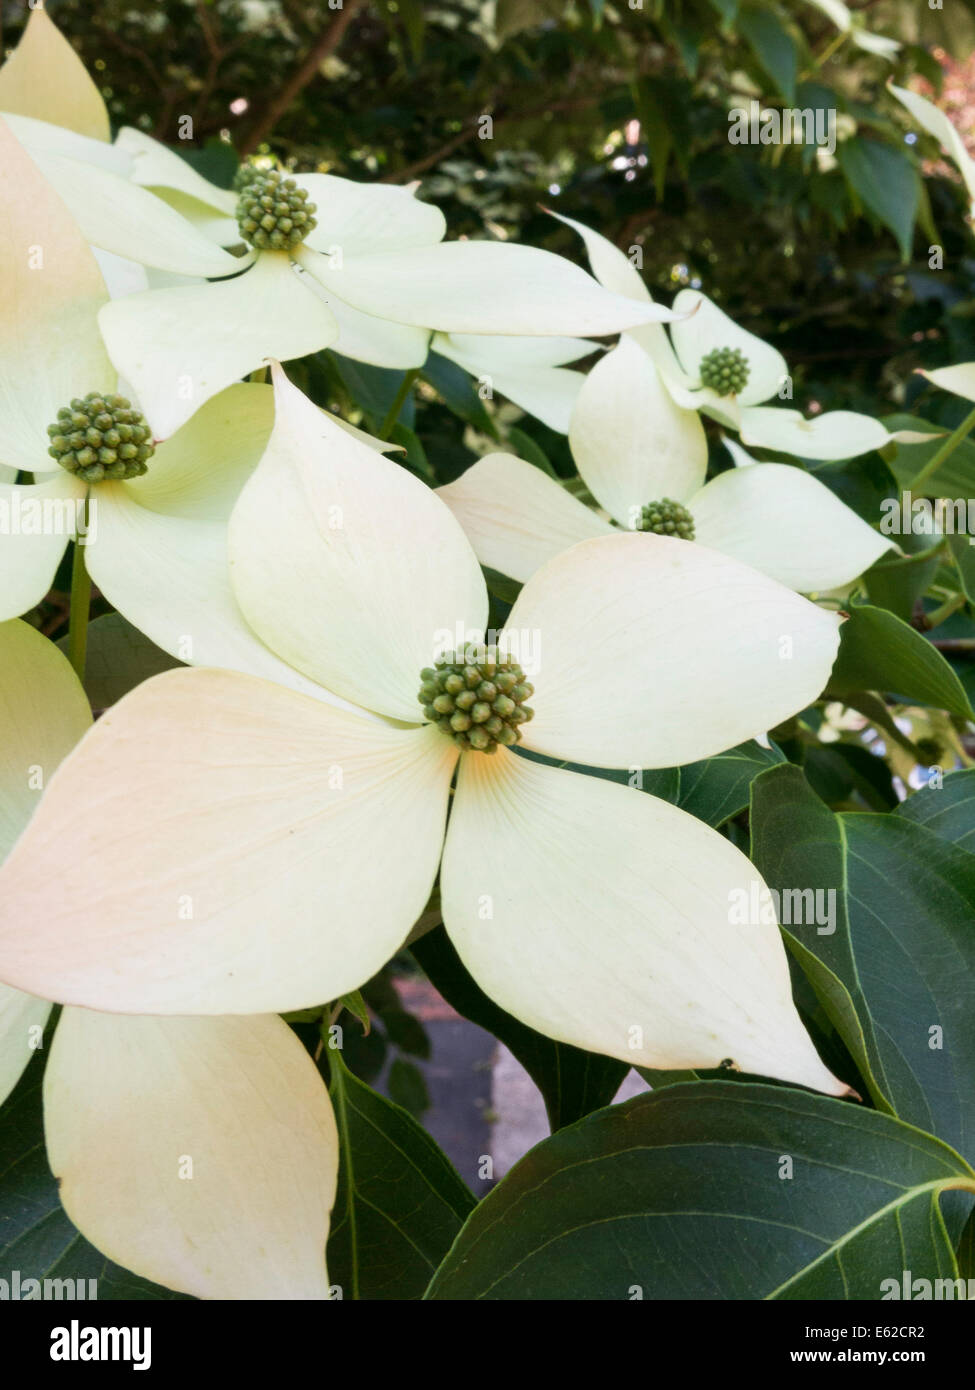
229, 366, 487, 721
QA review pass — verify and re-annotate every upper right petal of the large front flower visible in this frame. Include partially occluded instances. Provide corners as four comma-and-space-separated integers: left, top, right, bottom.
508, 534, 840, 767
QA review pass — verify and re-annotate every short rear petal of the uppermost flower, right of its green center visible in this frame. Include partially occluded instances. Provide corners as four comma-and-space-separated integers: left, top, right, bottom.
291, 174, 446, 259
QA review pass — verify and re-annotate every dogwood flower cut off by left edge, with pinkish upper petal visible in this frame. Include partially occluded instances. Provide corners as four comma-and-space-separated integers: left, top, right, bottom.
0, 122, 367, 691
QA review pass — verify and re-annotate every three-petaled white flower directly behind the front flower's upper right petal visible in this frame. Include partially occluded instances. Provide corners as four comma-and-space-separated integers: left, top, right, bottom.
440, 336, 892, 594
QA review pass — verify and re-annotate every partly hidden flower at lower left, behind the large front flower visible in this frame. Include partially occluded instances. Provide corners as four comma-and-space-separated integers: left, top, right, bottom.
0, 621, 338, 1300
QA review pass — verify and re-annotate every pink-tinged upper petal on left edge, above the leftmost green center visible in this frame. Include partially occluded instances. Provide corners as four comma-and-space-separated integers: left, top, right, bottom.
0, 121, 115, 471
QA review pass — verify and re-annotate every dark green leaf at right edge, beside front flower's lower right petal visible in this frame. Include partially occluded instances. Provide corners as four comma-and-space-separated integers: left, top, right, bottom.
751, 766, 975, 1155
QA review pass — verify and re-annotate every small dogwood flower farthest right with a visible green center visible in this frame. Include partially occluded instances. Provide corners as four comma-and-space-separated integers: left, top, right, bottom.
552, 213, 922, 461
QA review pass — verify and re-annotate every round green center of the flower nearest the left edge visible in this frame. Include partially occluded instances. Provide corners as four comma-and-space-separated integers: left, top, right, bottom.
47, 391, 156, 482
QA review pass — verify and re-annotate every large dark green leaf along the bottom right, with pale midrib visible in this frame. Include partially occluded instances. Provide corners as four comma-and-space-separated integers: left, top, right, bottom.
427, 1081, 975, 1301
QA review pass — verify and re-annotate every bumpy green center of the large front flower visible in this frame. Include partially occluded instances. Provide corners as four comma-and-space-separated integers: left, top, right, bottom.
417, 646, 534, 753
